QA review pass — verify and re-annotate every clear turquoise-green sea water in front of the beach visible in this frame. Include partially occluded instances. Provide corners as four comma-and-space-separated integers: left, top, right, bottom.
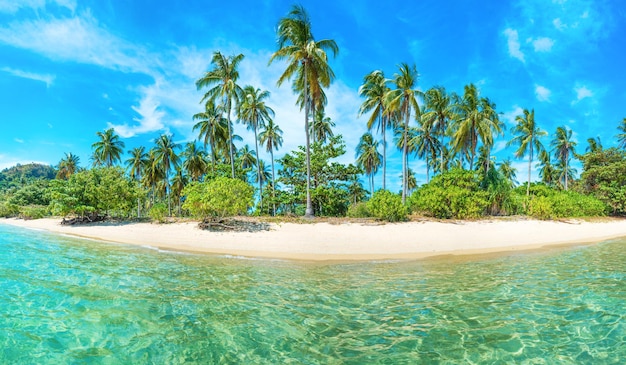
0, 224, 626, 364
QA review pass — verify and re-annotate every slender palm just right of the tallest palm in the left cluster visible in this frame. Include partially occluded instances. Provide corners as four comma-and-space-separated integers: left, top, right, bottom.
239, 85, 274, 209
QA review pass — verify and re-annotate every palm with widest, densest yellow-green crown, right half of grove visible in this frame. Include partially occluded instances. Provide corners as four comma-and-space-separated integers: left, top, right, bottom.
453, 84, 502, 170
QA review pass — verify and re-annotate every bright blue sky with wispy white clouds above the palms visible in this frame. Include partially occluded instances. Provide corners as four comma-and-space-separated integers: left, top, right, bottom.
0, 0, 626, 188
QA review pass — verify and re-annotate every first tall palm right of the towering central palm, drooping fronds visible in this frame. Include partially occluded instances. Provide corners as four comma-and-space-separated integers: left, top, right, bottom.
359, 70, 390, 190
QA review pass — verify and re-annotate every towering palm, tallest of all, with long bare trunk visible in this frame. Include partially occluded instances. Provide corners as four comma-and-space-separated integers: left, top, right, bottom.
269, 5, 339, 217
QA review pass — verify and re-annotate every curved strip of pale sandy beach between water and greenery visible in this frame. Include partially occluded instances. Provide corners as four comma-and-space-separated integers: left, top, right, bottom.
0, 218, 626, 262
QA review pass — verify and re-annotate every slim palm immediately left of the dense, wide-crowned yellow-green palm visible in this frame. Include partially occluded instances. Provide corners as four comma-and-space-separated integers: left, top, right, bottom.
422, 86, 454, 172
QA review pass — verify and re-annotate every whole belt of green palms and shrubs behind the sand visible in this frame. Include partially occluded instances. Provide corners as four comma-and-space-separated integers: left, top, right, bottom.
0, 6, 626, 222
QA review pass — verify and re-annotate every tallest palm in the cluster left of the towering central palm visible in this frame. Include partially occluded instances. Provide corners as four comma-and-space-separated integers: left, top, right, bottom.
196, 51, 243, 179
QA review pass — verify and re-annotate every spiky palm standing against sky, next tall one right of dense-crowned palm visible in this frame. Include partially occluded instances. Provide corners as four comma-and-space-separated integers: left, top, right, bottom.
507, 109, 548, 196
